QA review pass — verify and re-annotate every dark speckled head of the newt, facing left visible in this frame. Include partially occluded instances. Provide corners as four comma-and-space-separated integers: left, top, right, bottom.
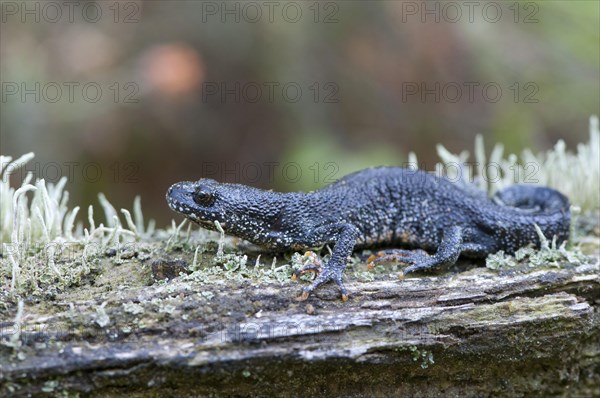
166, 178, 281, 244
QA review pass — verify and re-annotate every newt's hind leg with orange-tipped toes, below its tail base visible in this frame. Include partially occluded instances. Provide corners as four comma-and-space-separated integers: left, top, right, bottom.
369, 226, 463, 278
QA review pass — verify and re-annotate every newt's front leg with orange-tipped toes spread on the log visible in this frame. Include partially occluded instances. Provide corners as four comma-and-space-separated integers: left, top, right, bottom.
293, 224, 358, 301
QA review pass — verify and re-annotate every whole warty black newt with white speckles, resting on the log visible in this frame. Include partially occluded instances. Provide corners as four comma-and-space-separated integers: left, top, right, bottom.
166, 167, 570, 299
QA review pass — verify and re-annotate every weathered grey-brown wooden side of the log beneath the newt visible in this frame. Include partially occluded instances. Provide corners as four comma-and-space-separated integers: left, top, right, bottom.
0, 250, 600, 397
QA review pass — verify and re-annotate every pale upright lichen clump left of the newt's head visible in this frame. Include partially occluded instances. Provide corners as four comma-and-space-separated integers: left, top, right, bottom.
0, 153, 154, 296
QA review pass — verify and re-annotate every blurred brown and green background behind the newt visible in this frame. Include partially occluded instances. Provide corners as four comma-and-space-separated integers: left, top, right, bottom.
0, 1, 600, 225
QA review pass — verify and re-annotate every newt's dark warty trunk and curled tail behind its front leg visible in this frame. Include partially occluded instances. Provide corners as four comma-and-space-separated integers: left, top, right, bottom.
315, 167, 570, 254
